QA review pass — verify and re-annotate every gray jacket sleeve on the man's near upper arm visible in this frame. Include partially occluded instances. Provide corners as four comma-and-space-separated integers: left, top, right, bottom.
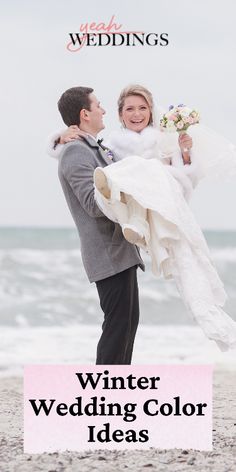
61, 146, 105, 218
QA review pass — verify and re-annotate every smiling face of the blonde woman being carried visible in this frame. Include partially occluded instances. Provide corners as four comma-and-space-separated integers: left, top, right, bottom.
120, 95, 151, 133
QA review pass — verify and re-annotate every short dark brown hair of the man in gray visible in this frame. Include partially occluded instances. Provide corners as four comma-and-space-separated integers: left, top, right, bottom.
57, 87, 93, 126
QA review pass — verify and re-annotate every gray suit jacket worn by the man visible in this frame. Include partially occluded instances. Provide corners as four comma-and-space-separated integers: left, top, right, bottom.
58, 137, 144, 282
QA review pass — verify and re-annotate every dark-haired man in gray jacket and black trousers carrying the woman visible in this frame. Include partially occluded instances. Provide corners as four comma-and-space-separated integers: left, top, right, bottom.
58, 87, 144, 364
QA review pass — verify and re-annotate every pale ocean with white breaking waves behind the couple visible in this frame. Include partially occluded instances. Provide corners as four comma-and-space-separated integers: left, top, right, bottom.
0, 227, 236, 375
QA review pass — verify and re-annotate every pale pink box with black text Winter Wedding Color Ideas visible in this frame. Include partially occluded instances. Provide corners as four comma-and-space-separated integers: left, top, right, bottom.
24, 365, 212, 453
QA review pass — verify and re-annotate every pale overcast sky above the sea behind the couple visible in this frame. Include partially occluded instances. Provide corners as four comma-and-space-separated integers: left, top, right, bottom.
0, 0, 236, 229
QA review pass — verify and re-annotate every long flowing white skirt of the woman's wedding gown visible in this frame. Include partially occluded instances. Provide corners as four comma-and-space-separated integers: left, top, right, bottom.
95, 156, 236, 351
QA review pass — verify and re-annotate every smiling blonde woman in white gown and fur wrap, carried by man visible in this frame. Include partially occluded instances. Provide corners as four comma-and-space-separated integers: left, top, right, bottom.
48, 86, 236, 351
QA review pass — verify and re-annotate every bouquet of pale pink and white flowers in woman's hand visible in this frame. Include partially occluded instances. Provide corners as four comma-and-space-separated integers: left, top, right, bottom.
160, 103, 200, 134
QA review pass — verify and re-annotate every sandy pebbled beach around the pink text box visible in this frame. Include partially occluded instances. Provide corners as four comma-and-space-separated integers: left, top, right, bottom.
0, 371, 236, 472
